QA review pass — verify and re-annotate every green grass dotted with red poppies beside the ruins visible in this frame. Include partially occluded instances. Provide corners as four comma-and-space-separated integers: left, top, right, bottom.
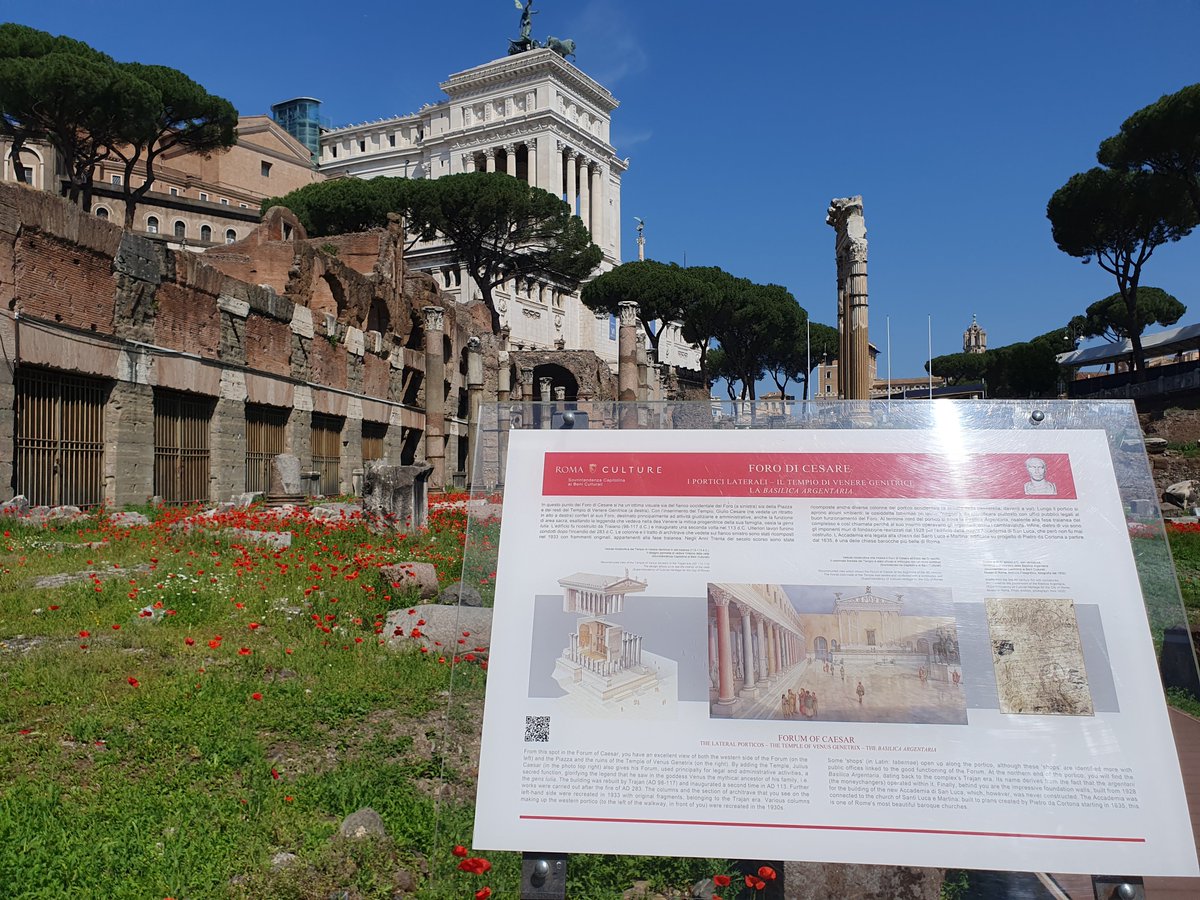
0, 508, 725, 900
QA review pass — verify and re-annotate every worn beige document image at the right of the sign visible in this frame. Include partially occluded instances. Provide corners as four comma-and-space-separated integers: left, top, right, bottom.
986, 598, 1096, 715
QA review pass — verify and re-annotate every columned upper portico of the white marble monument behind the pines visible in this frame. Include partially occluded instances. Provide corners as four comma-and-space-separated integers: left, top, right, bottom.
462, 136, 606, 235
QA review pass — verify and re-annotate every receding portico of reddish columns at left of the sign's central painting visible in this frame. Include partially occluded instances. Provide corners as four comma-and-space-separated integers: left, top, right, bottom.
708, 584, 806, 708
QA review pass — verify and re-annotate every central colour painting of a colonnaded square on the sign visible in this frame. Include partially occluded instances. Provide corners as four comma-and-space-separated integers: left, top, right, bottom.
708, 583, 967, 725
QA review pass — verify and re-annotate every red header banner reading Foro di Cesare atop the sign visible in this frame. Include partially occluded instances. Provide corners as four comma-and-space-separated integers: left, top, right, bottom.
542, 451, 1075, 500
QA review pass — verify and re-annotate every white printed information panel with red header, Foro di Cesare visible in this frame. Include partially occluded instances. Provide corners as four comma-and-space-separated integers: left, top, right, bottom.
474, 425, 1200, 876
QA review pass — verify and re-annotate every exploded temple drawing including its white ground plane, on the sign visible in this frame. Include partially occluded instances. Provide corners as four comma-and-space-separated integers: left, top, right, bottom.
554, 571, 678, 718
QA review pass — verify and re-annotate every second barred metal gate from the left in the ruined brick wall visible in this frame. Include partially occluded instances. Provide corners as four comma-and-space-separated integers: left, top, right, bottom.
154, 388, 215, 503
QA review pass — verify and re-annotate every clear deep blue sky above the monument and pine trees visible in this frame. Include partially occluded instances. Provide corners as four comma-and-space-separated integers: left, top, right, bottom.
9, 0, 1200, 377
